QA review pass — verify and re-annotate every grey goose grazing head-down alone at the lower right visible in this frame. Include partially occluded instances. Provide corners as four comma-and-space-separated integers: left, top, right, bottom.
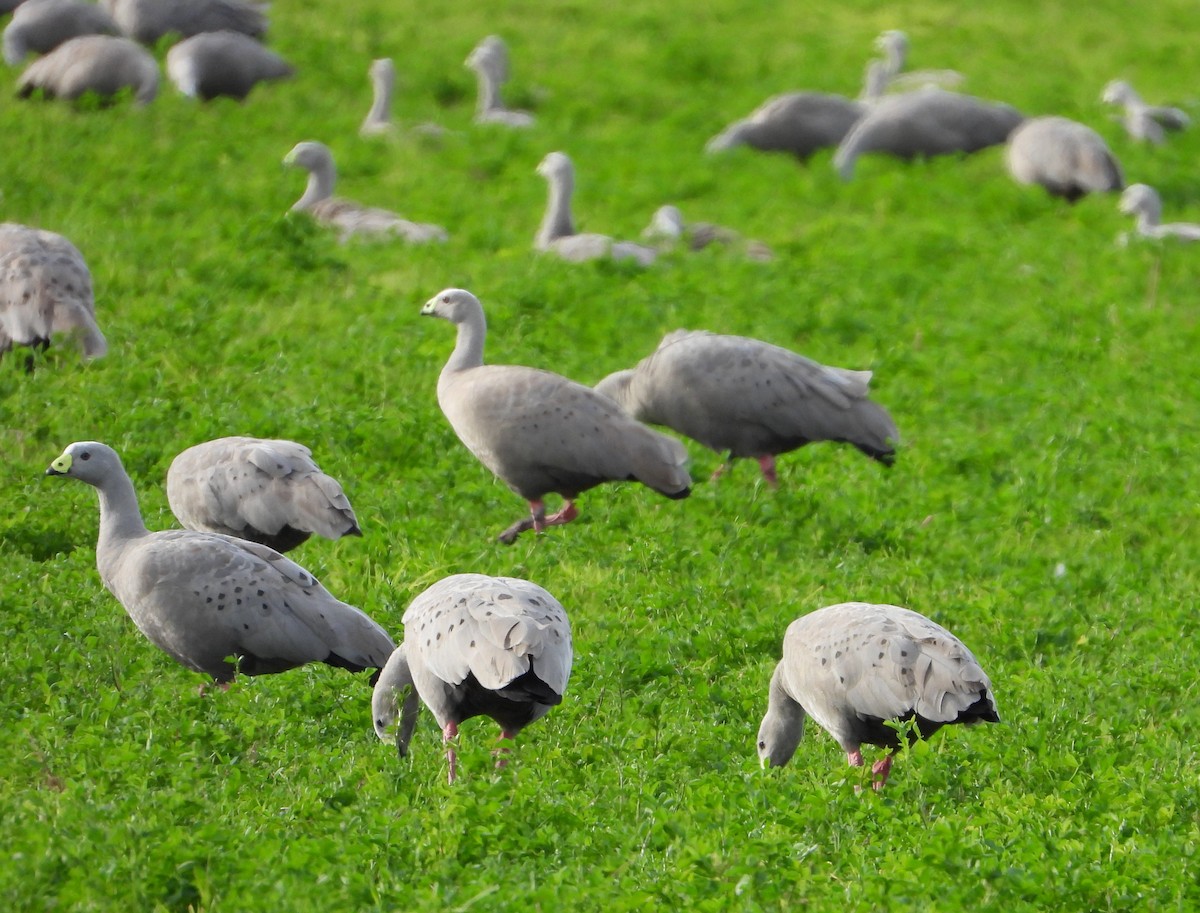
758, 602, 1000, 789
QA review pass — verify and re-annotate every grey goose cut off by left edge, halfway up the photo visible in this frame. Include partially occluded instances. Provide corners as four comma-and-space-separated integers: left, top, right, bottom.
0, 222, 108, 371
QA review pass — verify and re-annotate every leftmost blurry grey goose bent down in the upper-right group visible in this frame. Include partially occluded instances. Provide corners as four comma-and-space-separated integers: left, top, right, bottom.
704, 92, 866, 162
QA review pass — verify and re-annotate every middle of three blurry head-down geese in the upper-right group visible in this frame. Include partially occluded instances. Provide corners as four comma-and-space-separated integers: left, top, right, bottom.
833, 89, 1022, 180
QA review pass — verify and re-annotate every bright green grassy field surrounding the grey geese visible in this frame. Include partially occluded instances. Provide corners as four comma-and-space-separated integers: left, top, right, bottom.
0, 0, 1200, 913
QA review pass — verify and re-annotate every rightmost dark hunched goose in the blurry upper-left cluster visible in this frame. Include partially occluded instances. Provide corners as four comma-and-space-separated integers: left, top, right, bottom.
167, 30, 294, 101
